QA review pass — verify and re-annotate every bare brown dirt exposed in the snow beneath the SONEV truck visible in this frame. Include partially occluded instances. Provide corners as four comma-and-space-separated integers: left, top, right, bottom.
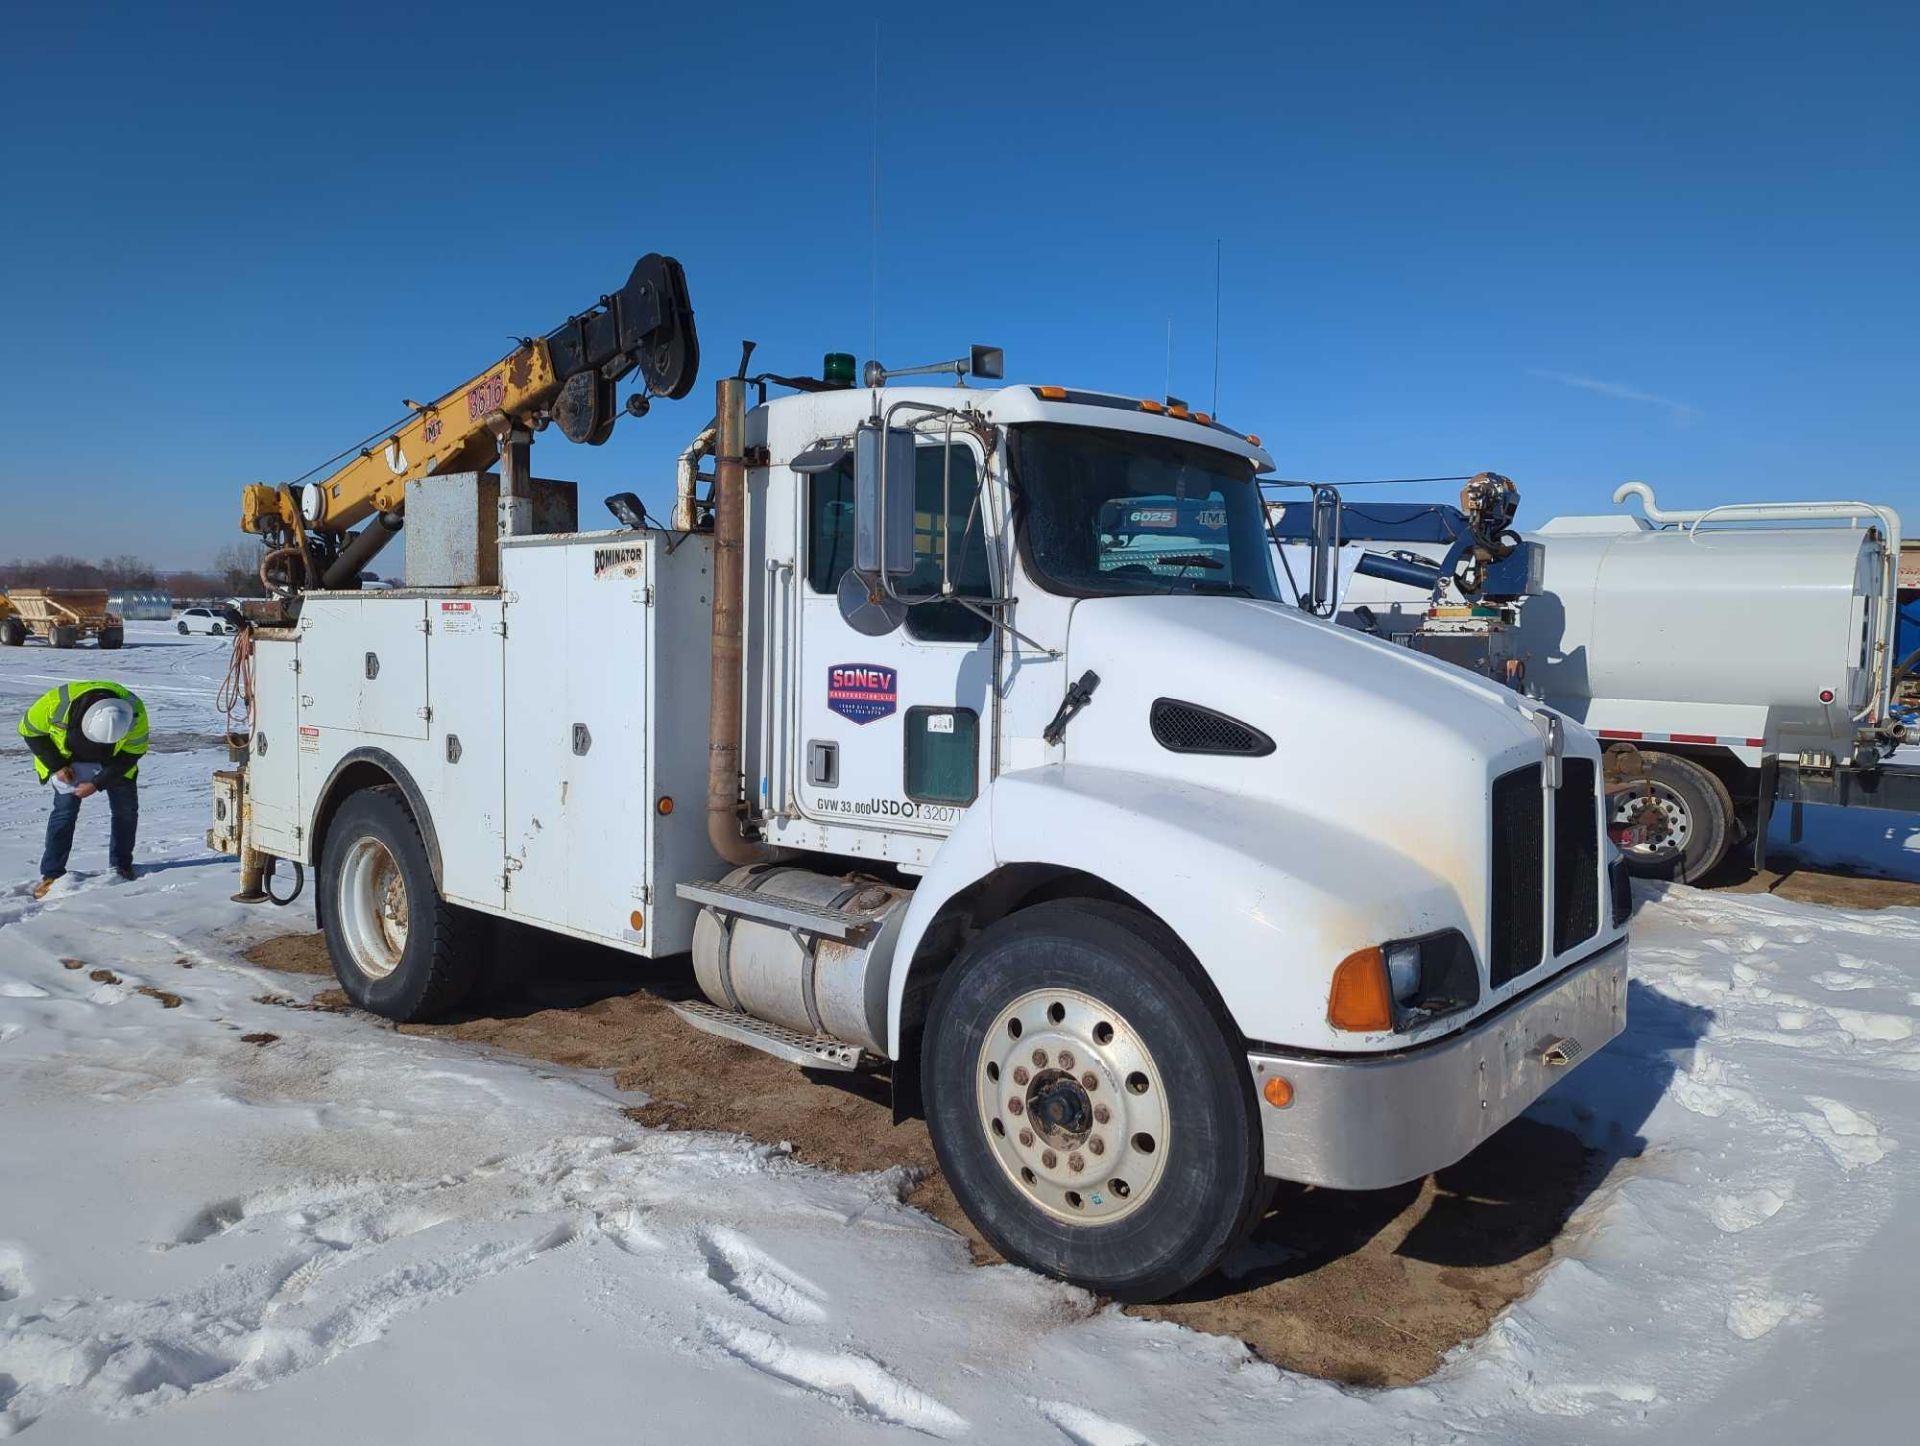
248, 933, 1597, 1385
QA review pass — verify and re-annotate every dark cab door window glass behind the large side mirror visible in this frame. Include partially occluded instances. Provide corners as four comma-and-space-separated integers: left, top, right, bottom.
806, 447, 993, 643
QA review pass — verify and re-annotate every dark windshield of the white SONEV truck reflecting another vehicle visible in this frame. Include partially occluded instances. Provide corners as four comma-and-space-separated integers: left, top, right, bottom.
1008, 422, 1279, 601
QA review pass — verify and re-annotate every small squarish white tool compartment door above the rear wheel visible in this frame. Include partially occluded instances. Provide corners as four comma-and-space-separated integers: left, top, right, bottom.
300, 595, 428, 737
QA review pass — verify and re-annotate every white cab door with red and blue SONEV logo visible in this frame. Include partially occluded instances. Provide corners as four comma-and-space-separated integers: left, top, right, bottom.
787, 438, 993, 833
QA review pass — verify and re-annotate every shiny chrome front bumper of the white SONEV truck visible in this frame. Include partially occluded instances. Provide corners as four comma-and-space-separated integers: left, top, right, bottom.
1246, 939, 1626, 1191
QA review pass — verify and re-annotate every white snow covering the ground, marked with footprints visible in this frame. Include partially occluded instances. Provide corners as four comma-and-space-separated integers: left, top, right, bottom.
0, 624, 1920, 1446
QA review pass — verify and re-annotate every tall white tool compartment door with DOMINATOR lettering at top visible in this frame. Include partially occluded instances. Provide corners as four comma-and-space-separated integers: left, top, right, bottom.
501, 540, 653, 952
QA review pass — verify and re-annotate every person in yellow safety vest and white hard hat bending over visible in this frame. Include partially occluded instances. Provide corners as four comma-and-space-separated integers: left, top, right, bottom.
19, 680, 148, 899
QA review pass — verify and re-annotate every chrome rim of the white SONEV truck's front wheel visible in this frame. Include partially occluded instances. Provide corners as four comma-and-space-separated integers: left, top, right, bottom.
975, 989, 1171, 1225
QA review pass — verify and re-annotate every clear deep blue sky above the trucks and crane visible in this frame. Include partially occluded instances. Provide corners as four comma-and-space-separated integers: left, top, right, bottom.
0, 0, 1920, 566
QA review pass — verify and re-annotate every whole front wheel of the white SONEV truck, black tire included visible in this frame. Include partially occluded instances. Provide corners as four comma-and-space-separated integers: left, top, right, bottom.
922, 901, 1261, 1302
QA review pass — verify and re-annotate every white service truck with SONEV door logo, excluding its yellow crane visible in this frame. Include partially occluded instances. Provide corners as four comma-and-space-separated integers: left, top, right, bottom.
215, 284, 1628, 1300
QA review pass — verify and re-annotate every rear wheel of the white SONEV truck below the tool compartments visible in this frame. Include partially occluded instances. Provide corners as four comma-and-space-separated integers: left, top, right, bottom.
321, 787, 484, 1024
